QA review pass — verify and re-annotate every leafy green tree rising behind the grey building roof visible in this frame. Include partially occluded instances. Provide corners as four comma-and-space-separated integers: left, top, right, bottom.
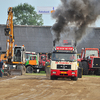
13, 3, 43, 25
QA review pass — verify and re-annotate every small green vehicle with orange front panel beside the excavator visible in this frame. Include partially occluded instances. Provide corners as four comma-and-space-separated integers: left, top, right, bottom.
25, 55, 40, 73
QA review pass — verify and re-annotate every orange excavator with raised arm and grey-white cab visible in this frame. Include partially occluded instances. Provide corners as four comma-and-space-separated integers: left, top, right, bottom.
4, 7, 26, 75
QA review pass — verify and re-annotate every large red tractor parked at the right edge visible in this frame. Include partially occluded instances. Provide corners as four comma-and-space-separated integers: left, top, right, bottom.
78, 48, 100, 75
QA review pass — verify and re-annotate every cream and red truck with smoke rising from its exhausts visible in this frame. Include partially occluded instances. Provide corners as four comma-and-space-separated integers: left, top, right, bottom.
46, 39, 82, 81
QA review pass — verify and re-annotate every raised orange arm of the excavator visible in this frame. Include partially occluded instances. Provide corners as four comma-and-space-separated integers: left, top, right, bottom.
4, 7, 14, 62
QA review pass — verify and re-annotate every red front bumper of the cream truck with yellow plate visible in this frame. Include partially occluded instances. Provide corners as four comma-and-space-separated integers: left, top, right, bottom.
51, 69, 77, 77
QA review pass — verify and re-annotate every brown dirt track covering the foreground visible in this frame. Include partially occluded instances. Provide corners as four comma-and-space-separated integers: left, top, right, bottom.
0, 75, 100, 100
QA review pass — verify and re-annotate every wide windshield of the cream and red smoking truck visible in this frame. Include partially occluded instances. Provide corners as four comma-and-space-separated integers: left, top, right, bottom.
52, 53, 77, 61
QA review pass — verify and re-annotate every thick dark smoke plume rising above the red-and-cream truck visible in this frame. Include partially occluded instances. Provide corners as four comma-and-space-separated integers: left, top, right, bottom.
52, 0, 100, 42
